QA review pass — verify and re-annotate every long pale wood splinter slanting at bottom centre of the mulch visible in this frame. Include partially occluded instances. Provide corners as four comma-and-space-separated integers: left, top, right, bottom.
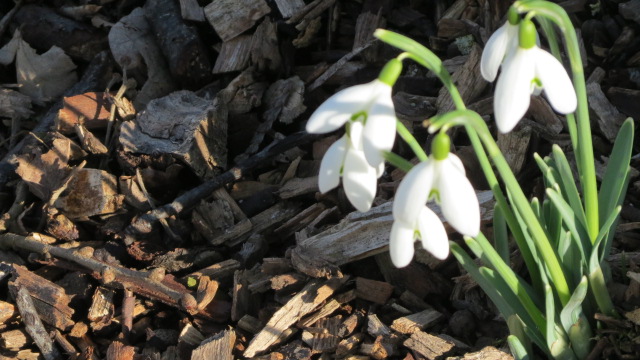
244, 277, 348, 357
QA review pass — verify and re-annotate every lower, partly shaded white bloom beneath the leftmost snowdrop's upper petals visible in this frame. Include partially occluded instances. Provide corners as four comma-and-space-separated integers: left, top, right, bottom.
318, 122, 384, 212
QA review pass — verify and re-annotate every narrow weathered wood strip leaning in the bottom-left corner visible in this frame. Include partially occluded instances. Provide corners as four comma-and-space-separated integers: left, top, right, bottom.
14, 287, 60, 360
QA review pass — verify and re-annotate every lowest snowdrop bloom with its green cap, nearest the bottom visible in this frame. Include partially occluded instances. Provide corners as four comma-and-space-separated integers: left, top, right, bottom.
389, 132, 480, 267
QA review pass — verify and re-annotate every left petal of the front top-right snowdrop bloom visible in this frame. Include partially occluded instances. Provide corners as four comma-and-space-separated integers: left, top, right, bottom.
493, 48, 534, 133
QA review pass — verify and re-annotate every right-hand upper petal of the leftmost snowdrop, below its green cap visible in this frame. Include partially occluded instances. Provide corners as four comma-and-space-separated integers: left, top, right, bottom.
362, 85, 396, 167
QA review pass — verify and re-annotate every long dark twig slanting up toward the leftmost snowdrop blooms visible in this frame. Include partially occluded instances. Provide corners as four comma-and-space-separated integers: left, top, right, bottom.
125, 131, 317, 241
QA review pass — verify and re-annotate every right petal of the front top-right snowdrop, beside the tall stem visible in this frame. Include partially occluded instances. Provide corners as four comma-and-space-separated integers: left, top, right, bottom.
535, 48, 578, 114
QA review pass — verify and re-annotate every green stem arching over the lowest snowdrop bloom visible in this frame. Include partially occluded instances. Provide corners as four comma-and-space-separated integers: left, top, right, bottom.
430, 110, 571, 305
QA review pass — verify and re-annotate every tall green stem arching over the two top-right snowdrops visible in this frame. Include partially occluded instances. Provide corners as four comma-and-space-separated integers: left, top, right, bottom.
513, 0, 600, 243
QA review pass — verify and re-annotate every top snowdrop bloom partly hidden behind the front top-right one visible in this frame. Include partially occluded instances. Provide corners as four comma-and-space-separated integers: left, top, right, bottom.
480, 7, 520, 82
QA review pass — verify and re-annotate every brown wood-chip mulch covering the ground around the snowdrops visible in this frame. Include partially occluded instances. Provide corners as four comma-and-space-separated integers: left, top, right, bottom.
0, 0, 640, 360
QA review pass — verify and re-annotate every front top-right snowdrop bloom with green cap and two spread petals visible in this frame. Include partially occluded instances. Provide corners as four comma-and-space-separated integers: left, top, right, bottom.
493, 20, 578, 133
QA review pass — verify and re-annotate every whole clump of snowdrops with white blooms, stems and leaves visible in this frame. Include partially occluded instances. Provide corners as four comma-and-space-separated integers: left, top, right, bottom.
306, 0, 633, 359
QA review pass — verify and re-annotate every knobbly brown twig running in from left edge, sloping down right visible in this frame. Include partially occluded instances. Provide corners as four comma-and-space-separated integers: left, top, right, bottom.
0, 233, 197, 313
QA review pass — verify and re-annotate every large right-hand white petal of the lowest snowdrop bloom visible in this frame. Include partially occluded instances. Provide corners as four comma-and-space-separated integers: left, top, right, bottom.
437, 159, 480, 236
